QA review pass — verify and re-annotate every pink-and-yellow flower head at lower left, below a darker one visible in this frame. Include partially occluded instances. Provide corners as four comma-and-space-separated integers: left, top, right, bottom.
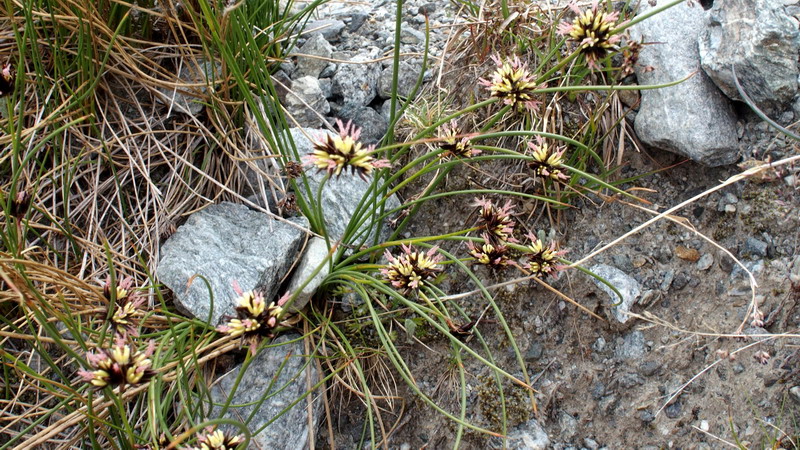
78, 335, 155, 389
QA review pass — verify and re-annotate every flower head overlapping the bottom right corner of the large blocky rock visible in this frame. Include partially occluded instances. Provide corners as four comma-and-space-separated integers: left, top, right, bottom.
217, 283, 289, 353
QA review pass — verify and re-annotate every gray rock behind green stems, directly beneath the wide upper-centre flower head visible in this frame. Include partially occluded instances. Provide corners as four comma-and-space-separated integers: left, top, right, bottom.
289, 128, 400, 242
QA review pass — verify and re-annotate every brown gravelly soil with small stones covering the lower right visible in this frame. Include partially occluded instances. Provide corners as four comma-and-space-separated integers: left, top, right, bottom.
323, 123, 800, 449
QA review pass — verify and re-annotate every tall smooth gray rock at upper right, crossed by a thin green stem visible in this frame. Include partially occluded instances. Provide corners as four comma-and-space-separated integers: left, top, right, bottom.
632, 2, 739, 166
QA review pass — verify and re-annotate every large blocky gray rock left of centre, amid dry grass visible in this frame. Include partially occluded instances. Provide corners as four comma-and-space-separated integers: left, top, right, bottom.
156, 203, 308, 326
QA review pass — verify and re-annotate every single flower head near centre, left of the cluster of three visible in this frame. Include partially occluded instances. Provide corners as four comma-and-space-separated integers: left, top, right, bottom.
381, 245, 443, 294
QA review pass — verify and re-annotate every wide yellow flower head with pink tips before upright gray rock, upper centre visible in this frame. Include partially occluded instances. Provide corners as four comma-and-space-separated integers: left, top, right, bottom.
303, 119, 389, 179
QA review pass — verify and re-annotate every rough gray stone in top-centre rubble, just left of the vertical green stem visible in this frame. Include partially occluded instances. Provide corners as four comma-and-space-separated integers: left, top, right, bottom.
331, 48, 381, 108
